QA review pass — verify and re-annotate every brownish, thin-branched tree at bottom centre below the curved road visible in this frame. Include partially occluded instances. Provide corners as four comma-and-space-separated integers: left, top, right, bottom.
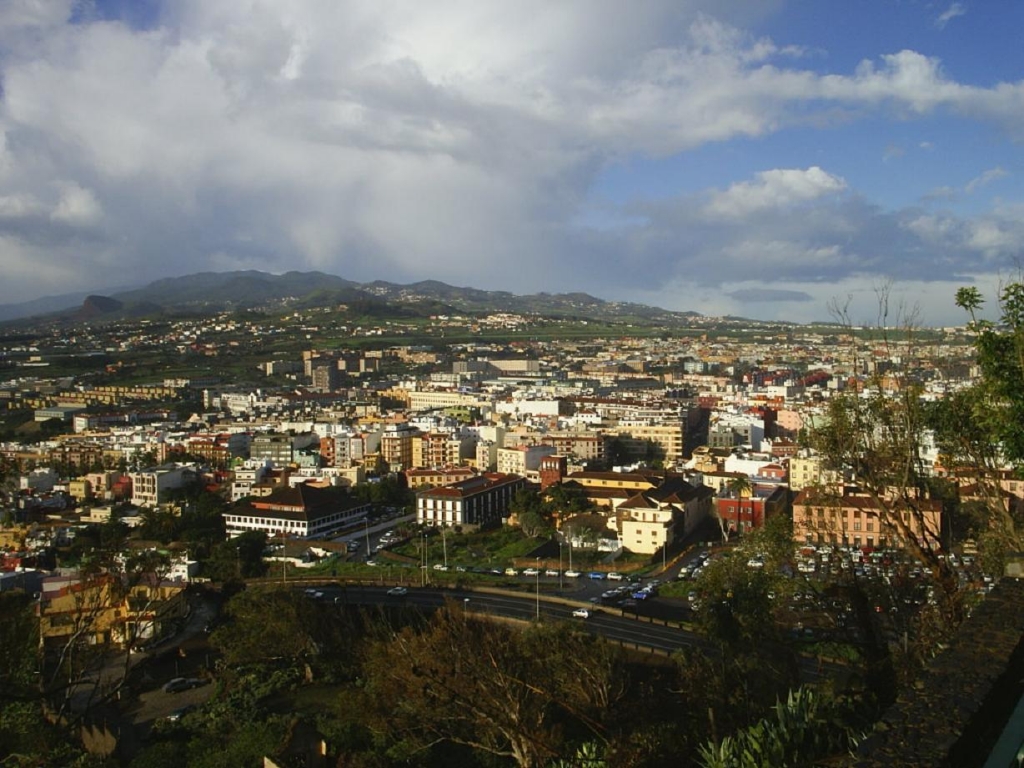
364, 608, 621, 768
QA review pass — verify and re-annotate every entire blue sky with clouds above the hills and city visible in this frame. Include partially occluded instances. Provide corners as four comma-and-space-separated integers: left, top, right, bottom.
0, 0, 1024, 326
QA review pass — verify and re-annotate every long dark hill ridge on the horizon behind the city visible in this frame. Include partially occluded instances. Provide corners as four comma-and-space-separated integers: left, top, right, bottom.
0, 270, 700, 325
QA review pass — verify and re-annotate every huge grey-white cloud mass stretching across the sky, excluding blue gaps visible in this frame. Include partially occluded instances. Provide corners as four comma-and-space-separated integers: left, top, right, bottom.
0, 0, 1024, 323
